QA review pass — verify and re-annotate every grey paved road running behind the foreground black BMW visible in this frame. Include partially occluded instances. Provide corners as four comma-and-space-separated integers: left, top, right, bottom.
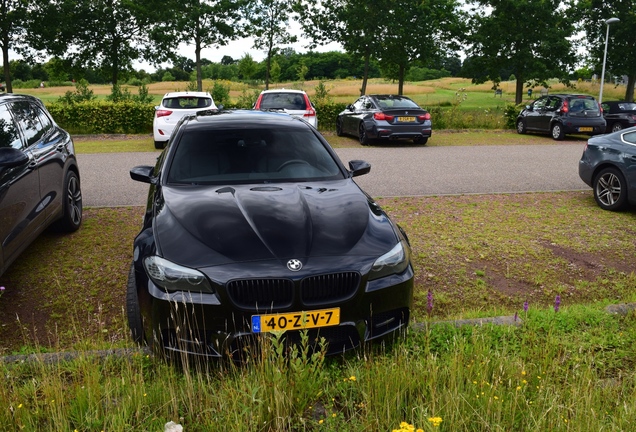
78, 143, 589, 206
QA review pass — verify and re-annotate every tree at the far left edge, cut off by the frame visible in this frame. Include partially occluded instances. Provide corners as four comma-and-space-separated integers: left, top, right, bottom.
0, 0, 28, 93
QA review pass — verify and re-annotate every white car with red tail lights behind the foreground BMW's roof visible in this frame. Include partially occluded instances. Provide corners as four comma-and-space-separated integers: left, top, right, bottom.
254, 89, 318, 129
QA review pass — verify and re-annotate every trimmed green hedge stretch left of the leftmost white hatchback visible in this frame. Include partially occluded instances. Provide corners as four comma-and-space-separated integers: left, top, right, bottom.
47, 100, 155, 134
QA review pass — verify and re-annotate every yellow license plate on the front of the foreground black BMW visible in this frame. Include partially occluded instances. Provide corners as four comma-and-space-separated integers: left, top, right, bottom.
252, 308, 340, 333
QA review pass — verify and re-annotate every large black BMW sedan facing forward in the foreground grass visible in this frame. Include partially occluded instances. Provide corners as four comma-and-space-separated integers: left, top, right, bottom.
127, 111, 413, 357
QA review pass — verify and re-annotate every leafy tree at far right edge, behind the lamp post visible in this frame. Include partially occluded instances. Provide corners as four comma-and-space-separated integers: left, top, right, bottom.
578, 0, 636, 102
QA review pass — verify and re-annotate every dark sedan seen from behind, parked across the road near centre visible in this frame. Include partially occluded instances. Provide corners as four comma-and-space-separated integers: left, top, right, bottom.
336, 95, 432, 145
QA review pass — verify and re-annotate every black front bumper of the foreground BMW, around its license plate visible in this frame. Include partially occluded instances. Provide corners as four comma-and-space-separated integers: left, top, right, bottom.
137, 266, 413, 358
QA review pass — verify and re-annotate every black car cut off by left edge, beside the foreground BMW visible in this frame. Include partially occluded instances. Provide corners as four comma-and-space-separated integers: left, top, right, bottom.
0, 94, 82, 275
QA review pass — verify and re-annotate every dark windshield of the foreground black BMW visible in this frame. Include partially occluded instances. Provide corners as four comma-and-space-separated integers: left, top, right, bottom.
168, 126, 344, 184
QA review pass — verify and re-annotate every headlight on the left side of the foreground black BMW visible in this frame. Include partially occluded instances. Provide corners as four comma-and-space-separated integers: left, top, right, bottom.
144, 256, 214, 292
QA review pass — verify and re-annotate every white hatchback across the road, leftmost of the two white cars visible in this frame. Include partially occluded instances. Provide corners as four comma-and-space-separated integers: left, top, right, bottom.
152, 92, 217, 149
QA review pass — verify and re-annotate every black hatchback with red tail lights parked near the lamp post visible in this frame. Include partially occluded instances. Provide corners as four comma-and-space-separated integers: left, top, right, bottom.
517, 94, 605, 140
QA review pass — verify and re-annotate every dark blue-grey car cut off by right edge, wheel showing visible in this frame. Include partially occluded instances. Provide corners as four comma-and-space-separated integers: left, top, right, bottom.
579, 127, 636, 210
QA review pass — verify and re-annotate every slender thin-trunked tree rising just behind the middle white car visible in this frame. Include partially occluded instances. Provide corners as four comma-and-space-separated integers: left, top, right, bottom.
249, 0, 296, 90
